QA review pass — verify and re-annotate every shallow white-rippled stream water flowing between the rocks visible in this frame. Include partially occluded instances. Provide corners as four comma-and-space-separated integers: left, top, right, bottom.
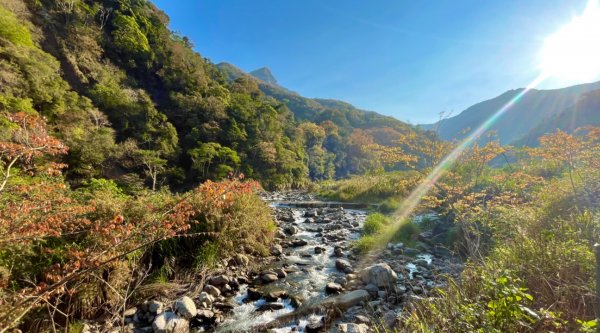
217, 195, 366, 333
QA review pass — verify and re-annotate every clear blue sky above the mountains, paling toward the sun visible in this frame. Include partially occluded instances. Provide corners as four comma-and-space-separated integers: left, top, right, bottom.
153, 0, 586, 124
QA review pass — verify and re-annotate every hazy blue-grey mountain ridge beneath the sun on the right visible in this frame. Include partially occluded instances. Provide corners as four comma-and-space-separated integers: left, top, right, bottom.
422, 82, 600, 146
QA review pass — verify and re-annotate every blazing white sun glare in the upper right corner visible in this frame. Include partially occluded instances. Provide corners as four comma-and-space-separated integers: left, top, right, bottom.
540, 0, 600, 82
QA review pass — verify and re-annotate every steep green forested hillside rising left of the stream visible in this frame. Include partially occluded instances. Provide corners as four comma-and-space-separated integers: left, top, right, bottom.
0, 0, 432, 189
